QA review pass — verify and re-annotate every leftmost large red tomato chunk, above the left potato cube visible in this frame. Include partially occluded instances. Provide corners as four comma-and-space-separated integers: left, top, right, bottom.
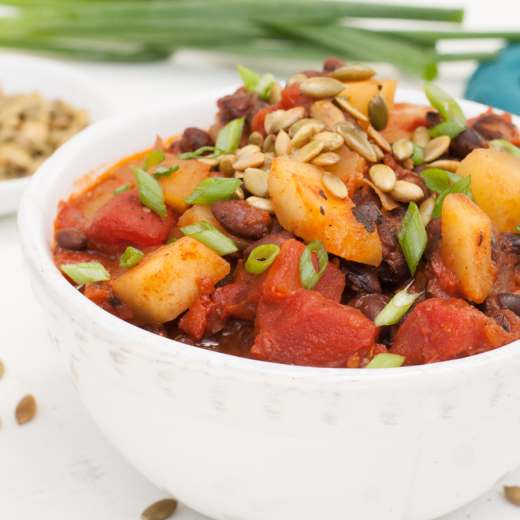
87, 190, 179, 247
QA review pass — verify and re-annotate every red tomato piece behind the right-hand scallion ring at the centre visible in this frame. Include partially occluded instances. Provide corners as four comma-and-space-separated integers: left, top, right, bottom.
263, 239, 346, 302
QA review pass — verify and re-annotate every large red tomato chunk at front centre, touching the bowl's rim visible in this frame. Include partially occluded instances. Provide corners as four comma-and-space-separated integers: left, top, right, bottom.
251, 289, 378, 368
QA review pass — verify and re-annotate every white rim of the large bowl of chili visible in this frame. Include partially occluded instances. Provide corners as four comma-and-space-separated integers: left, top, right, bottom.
18, 87, 520, 383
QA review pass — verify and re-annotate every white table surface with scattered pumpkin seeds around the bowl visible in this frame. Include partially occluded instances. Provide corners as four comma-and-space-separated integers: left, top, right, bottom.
0, 0, 520, 520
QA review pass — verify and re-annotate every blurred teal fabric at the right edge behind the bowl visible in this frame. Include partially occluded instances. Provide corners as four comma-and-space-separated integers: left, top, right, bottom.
465, 44, 520, 115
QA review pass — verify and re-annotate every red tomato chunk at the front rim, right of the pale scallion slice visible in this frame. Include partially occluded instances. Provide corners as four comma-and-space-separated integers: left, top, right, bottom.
390, 298, 520, 365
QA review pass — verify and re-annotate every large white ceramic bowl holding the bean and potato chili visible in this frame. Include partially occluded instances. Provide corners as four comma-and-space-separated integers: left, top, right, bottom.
19, 91, 520, 520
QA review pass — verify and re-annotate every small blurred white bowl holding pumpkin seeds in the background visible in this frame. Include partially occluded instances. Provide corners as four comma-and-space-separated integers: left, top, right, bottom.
0, 52, 111, 217
